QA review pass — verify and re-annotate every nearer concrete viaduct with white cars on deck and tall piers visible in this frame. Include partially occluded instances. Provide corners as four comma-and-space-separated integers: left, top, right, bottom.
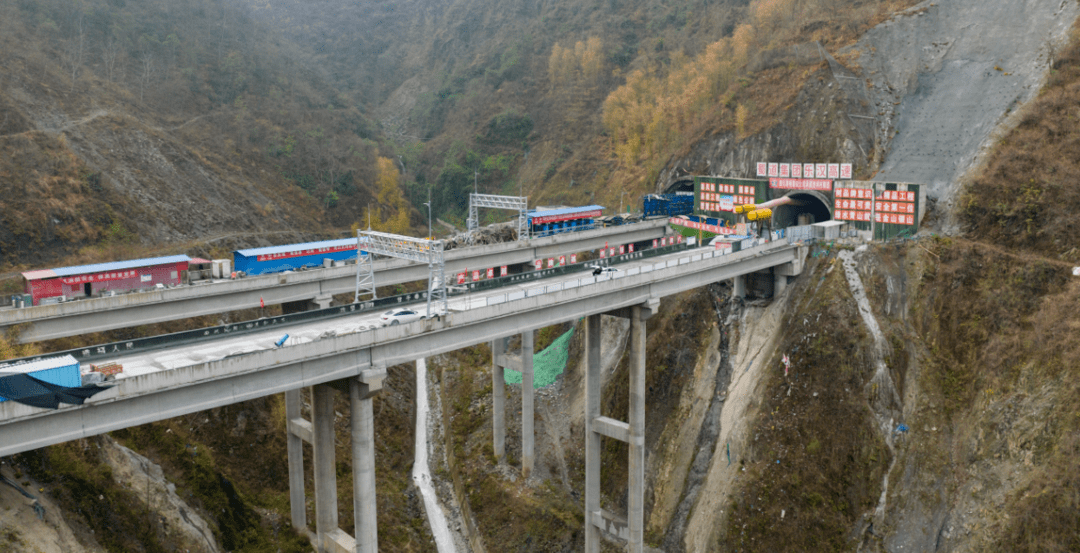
0, 241, 807, 553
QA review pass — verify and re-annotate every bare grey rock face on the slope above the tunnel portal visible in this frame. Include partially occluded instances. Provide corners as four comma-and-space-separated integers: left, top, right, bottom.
854, 0, 1080, 220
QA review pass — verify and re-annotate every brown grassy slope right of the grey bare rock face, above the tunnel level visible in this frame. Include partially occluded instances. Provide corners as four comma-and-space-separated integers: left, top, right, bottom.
961, 26, 1080, 262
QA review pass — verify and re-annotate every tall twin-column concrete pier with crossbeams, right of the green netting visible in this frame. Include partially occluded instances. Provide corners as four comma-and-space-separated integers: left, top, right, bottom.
585, 300, 660, 553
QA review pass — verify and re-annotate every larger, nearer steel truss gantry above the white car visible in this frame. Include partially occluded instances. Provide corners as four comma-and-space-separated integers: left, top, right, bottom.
356, 230, 449, 318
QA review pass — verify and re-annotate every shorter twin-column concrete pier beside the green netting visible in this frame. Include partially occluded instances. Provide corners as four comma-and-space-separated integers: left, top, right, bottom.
491, 331, 536, 478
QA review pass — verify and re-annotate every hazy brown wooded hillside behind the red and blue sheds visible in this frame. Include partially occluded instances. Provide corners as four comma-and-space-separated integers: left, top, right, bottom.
0, 0, 414, 272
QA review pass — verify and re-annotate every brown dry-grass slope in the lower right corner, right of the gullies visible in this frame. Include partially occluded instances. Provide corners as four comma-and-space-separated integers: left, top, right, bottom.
912, 240, 1080, 552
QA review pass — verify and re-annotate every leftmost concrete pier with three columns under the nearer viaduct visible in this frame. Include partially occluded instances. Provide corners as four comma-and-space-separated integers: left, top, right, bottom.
285, 368, 387, 553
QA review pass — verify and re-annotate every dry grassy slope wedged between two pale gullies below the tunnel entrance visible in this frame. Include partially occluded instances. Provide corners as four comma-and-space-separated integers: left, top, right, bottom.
716, 251, 891, 552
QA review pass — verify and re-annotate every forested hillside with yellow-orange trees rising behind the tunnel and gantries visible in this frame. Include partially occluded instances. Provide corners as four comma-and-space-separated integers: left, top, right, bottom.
240, 0, 915, 218
